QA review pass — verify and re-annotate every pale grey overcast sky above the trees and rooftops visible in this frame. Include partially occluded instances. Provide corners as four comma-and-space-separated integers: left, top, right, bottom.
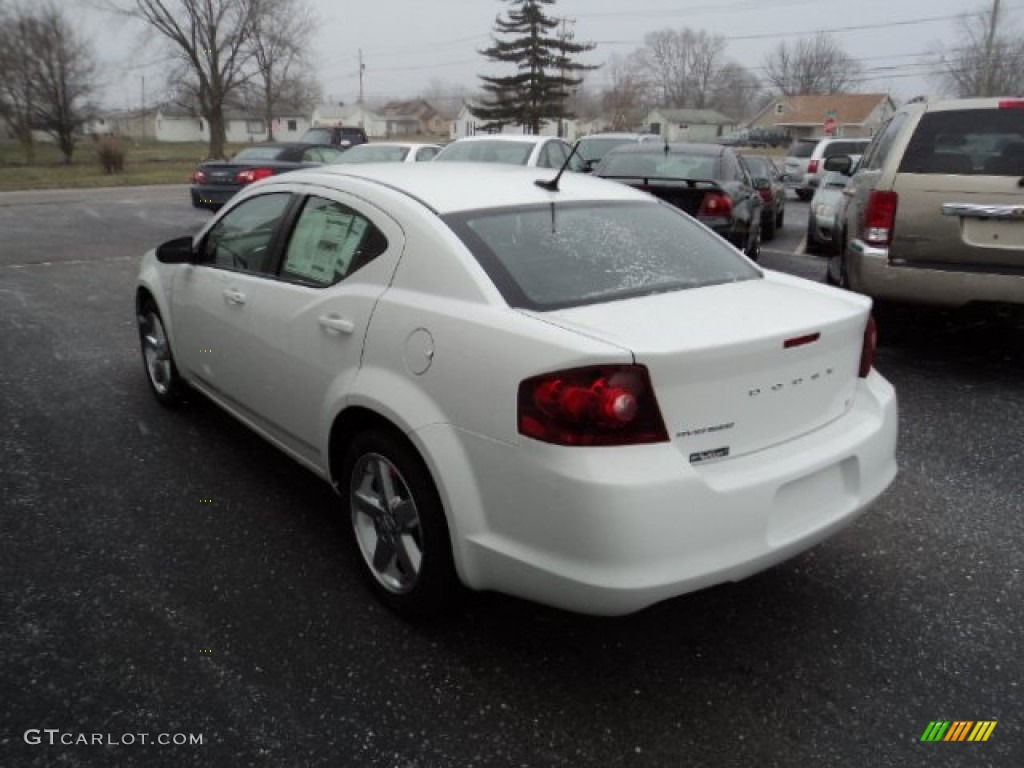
81, 0, 1024, 108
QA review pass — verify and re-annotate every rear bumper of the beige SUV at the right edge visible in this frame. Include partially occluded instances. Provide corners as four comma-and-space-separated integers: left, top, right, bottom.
846, 240, 1024, 307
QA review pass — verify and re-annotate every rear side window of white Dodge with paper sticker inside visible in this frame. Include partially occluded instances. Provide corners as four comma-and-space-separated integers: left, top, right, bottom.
281, 198, 387, 287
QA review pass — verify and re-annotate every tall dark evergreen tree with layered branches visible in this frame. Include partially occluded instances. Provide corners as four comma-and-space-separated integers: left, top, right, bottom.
472, 0, 596, 133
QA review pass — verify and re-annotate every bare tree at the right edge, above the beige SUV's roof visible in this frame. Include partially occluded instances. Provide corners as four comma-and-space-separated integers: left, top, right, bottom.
935, 3, 1024, 98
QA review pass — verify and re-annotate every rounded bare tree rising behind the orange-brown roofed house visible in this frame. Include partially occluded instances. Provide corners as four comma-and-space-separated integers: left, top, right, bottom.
764, 32, 860, 96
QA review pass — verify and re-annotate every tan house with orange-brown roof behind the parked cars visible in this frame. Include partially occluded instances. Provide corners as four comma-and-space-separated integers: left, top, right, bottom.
750, 93, 896, 138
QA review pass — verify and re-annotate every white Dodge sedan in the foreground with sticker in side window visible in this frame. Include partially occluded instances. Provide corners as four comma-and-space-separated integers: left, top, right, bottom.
135, 163, 897, 614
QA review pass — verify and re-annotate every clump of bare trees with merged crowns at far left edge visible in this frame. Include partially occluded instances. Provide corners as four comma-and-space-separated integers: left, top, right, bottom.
0, 3, 96, 164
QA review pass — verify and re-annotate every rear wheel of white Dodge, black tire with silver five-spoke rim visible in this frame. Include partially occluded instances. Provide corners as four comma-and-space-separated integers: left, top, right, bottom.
339, 429, 462, 616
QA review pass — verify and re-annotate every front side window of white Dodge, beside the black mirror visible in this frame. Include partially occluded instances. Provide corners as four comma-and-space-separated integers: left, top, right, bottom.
203, 193, 292, 274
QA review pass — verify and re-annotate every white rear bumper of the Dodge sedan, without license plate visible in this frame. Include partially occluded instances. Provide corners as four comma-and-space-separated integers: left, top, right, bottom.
432, 373, 897, 615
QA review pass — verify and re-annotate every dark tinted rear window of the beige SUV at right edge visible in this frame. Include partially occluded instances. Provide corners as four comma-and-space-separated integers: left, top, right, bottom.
899, 110, 1024, 176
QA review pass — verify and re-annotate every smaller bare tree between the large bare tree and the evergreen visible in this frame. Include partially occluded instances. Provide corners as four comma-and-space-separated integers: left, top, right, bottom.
248, 0, 315, 140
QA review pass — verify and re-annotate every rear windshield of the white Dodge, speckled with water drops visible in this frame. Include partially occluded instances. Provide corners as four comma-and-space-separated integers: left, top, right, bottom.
444, 201, 761, 310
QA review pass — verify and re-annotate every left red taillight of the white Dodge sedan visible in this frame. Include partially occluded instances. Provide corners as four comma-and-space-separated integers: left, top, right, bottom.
518, 366, 669, 445
